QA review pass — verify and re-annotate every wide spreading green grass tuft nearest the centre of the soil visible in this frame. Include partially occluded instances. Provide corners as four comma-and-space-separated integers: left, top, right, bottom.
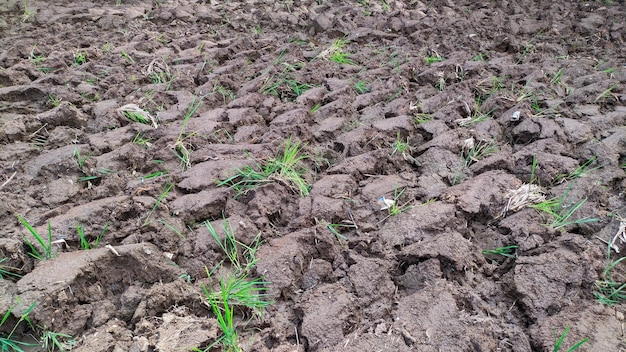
218, 137, 310, 197
